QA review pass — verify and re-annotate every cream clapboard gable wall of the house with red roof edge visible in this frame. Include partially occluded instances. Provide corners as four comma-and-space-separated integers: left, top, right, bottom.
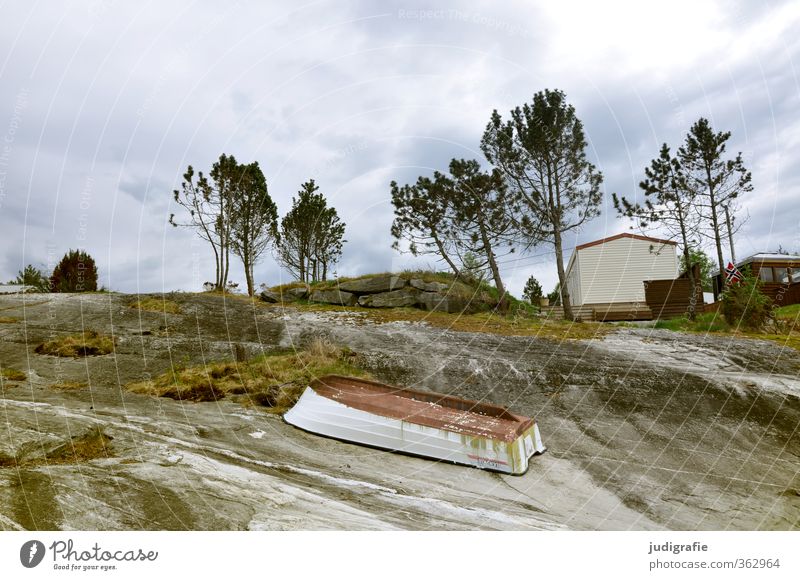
576, 238, 678, 304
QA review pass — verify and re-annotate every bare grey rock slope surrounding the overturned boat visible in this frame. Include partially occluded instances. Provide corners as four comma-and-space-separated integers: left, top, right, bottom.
0, 294, 800, 530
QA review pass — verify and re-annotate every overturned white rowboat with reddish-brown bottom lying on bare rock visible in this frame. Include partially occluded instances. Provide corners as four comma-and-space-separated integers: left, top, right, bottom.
284, 375, 546, 475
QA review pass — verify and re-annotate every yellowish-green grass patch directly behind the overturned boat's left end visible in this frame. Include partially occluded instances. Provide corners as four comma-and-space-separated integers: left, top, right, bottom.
127, 339, 369, 413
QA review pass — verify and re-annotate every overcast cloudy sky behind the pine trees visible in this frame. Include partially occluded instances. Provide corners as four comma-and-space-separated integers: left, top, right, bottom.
0, 0, 800, 294
